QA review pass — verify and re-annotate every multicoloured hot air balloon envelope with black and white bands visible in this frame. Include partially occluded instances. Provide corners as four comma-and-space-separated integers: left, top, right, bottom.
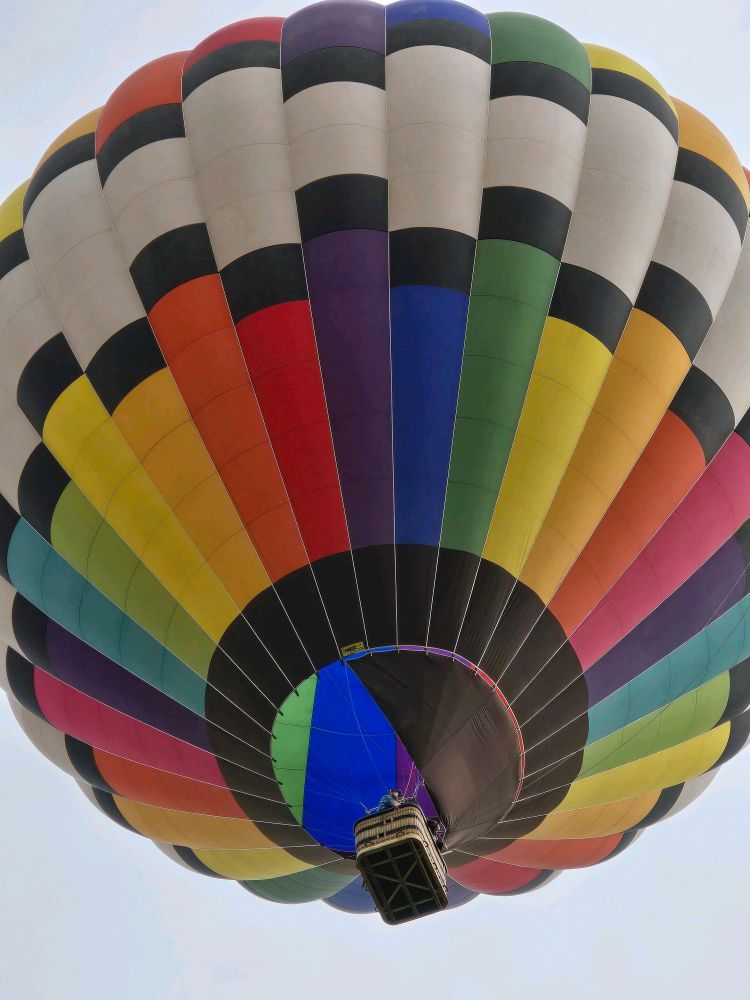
0, 0, 750, 913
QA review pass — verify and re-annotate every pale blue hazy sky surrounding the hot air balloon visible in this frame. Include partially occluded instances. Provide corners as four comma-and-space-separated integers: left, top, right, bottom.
0, 0, 750, 1000
